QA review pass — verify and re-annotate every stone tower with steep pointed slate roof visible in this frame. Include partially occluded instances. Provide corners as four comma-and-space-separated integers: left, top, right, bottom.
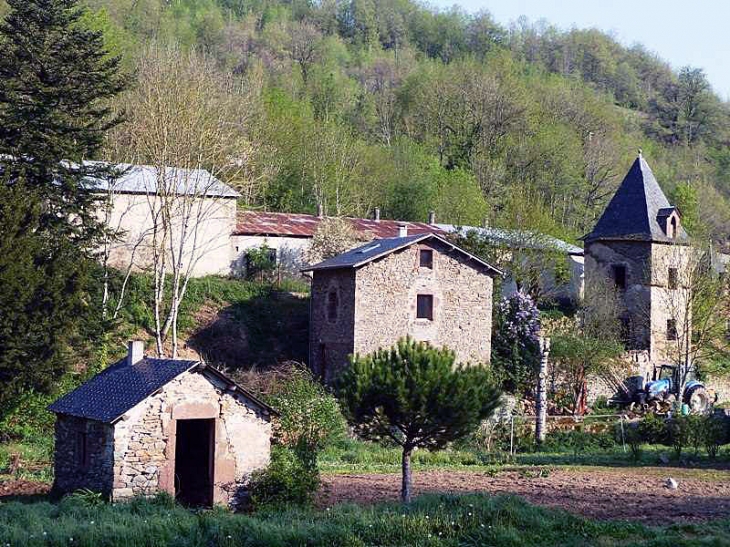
583, 153, 691, 364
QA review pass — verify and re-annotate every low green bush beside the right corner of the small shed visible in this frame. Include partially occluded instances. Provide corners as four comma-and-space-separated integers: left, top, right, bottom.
250, 446, 319, 508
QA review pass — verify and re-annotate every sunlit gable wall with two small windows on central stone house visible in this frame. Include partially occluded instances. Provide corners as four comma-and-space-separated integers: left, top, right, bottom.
354, 241, 493, 363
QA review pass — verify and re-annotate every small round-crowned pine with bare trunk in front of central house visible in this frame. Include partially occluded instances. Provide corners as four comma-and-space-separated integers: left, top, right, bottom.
338, 338, 500, 503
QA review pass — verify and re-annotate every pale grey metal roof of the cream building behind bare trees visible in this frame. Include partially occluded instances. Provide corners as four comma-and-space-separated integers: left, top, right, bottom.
87, 162, 240, 198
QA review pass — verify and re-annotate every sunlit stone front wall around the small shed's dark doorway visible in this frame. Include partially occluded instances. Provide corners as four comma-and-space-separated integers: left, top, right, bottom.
113, 372, 271, 506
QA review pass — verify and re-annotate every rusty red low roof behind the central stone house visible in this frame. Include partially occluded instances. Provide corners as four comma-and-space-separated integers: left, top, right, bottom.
233, 211, 443, 239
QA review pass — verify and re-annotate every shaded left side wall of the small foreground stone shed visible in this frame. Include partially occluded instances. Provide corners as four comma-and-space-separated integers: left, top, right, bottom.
53, 415, 114, 496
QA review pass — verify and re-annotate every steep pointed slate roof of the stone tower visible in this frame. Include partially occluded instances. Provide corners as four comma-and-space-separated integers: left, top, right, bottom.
583, 155, 689, 243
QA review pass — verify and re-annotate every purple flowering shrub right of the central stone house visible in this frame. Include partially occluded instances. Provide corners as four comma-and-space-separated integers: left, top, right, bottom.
492, 291, 540, 395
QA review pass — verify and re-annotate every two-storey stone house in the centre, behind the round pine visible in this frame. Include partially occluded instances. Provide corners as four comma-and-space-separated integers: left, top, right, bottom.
306, 228, 501, 382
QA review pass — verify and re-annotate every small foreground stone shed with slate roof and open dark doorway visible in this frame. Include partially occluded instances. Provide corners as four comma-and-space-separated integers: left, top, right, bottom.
49, 342, 275, 507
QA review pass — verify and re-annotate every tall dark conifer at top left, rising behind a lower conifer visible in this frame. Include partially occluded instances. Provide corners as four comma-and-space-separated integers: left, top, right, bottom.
0, 0, 126, 245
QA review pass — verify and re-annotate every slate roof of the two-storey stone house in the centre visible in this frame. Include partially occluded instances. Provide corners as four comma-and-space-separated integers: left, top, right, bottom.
302, 234, 502, 275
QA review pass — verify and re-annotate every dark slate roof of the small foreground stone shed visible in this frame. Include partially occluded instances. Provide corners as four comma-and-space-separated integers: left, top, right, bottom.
48, 357, 276, 423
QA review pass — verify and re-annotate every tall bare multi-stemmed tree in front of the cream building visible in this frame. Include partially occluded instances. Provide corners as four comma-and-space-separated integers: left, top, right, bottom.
108, 49, 251, 358
